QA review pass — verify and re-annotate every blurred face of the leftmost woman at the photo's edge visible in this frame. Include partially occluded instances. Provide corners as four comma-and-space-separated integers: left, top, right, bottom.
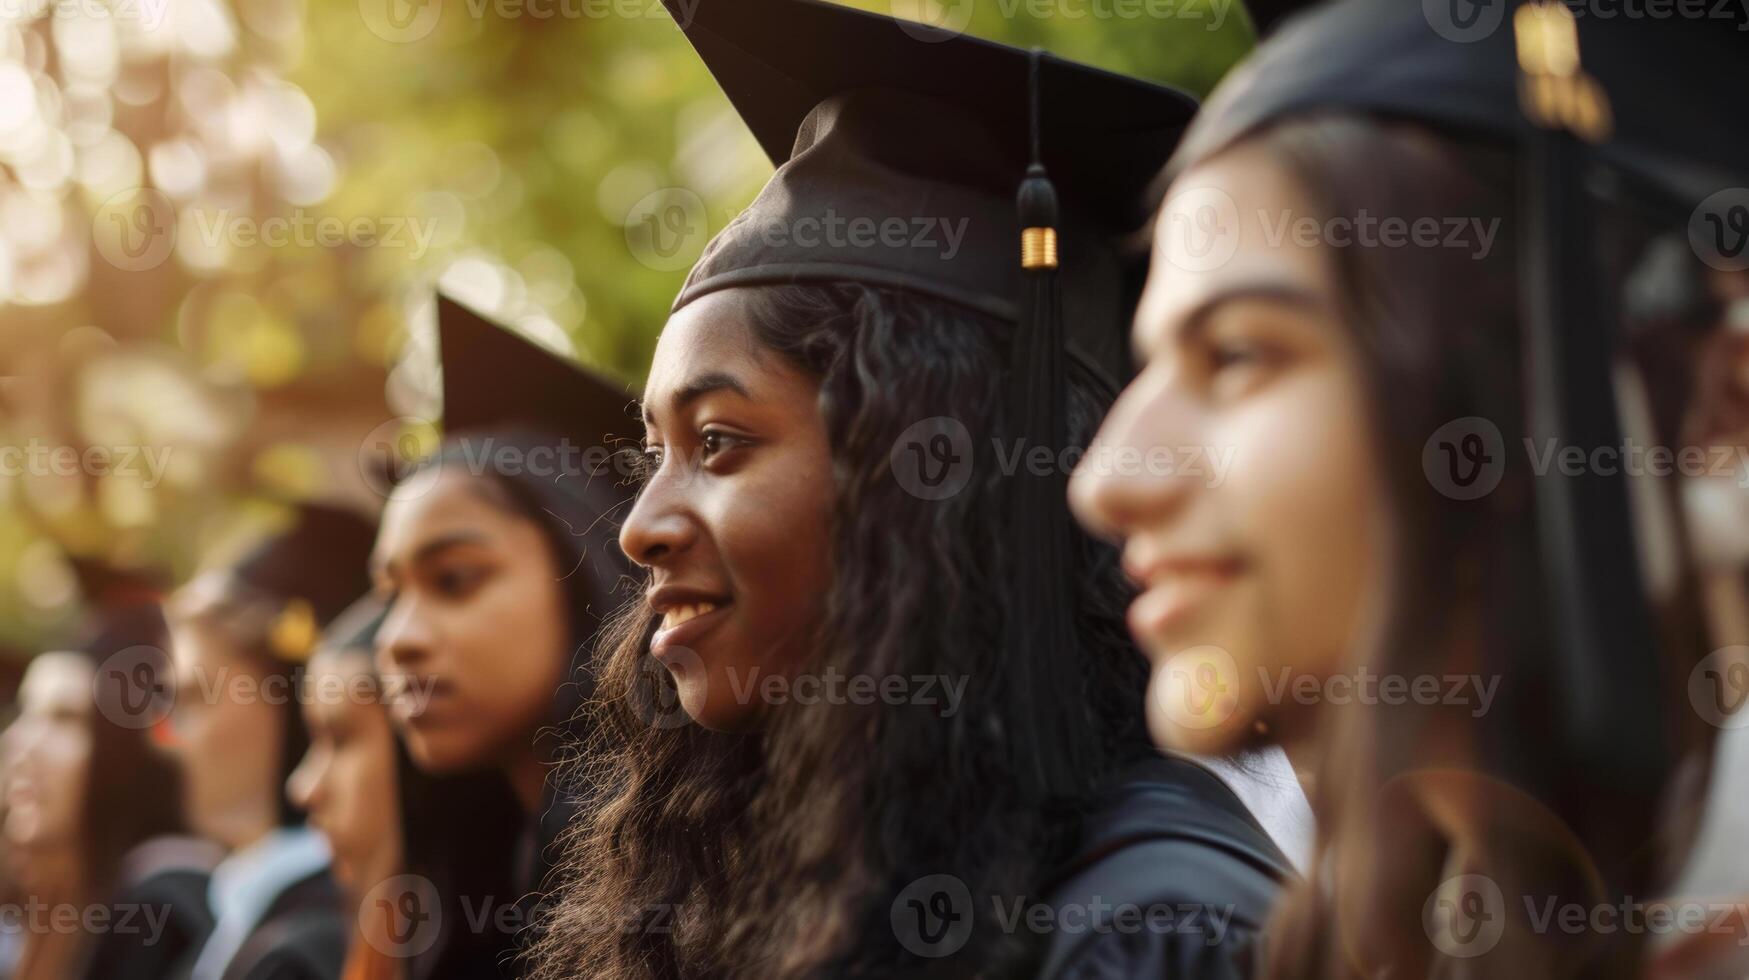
5, 653, 94, 871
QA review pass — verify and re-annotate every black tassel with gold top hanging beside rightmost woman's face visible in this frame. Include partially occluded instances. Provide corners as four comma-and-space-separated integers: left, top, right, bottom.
1502, 0, 1670, 924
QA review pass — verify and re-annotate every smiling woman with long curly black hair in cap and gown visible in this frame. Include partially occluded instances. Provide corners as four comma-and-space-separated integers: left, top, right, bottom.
517, 0, 1286, 980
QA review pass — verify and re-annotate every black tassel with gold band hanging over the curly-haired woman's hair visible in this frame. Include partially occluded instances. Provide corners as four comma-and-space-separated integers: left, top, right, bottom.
1006, 49, 1086, 798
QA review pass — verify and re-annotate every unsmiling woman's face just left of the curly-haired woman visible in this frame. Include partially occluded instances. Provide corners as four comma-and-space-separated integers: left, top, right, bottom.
371, 466, 572, 772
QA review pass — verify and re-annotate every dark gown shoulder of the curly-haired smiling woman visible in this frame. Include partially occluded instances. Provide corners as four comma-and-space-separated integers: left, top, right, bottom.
1039, 756, 1294, 980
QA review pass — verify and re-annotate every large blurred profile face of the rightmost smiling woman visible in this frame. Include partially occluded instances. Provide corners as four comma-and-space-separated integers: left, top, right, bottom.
1070, 144, 1383, 751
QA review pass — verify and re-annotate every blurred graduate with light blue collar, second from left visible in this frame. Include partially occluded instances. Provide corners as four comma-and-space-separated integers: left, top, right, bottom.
168, 504, 374, 980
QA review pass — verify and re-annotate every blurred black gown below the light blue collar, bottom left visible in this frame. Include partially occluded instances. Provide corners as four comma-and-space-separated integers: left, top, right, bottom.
224, 868, 352, 980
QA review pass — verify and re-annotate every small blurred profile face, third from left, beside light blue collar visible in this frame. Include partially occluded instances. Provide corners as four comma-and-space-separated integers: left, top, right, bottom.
285, 649, 401, 893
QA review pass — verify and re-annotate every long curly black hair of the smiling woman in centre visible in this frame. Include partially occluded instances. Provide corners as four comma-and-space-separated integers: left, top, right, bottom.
528, 285, 1151, 978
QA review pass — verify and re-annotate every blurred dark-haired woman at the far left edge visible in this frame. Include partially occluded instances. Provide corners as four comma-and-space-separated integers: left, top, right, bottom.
0, 560, 180, 978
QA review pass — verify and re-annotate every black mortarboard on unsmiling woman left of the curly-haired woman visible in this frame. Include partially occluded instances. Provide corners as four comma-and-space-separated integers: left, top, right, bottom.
437, 294, 637, 446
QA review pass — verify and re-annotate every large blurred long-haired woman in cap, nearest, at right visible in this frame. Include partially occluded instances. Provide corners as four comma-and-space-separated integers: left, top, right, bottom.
1072, 0, 1749, 978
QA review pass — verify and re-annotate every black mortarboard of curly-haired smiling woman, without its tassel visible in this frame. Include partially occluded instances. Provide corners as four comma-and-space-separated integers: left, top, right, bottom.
670, 0, 1196, 385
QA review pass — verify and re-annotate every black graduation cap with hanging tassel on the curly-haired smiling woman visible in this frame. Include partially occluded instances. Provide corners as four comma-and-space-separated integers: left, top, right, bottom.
666, 0, 1196, 791
